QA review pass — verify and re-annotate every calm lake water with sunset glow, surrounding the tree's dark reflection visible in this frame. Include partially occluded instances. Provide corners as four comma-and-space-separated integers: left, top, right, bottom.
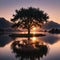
0, 34, 60, 60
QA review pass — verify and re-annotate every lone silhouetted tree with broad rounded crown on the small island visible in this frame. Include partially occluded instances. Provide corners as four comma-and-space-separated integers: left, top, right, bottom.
11, 7, 49, 35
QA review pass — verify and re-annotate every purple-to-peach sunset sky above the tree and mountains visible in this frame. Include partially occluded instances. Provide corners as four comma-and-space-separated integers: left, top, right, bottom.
0, 0, 60, 24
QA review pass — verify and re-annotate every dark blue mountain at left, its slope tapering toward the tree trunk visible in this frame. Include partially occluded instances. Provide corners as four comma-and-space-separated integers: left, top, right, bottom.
0, 18, 22, 34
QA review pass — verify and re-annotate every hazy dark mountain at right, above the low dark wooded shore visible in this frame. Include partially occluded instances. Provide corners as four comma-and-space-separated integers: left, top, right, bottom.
43, 21, 60, 30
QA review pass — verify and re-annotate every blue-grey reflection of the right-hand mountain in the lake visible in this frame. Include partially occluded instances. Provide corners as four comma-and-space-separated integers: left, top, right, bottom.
39, 35, 60, 44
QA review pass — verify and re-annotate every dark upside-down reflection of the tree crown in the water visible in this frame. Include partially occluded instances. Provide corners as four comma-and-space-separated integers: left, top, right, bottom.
11, 40, 48, 60
